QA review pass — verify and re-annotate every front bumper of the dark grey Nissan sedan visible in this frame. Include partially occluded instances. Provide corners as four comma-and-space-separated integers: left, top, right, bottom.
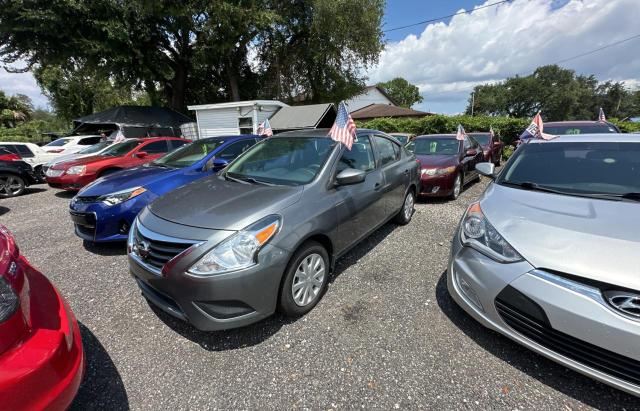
128, 219, 290, 331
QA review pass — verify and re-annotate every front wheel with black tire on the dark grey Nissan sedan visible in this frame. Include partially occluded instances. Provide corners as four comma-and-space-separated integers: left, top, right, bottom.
278, 241, 330, 318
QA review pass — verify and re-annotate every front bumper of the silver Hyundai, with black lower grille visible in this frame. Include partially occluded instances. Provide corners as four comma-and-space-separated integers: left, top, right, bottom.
447, 234, 640, 396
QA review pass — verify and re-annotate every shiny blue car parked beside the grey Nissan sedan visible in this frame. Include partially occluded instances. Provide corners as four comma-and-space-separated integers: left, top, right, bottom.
69, 135, 260, 242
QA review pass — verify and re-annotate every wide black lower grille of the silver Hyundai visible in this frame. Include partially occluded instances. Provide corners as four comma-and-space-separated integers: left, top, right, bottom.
495, 296, 640, 386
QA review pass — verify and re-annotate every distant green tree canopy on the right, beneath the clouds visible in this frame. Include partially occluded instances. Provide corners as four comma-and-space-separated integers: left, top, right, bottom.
466, 65, 640, 121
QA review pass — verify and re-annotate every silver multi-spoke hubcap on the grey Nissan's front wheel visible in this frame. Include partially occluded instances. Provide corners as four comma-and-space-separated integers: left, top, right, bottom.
291, 253, 326, 307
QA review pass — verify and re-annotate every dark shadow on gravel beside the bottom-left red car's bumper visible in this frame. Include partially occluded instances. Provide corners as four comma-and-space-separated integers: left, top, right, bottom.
70, 322, 129, 410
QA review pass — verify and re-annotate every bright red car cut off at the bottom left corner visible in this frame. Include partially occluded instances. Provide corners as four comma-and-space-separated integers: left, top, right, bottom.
0, 225, 84, 410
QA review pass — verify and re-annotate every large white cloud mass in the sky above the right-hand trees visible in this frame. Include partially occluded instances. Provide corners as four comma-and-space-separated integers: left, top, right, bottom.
368, 0, 640, 112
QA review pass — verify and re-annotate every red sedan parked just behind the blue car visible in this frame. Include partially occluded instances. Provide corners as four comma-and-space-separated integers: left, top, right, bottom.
45, 137, 189, 191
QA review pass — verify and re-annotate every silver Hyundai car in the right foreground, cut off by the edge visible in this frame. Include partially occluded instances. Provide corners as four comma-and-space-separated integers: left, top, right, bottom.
447, 134, 640, 395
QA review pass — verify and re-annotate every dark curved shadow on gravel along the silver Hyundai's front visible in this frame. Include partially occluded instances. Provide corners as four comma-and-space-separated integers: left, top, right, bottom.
436, 271, 638, 409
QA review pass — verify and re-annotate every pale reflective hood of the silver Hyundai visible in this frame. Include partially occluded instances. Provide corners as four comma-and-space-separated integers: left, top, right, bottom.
480, 184, 640, 290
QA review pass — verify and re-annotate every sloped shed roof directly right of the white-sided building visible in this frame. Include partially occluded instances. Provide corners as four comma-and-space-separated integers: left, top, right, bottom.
269, 103, 336, 130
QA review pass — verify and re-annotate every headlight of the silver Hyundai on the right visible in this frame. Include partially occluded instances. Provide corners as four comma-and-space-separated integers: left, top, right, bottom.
460, 203, 523, 263
